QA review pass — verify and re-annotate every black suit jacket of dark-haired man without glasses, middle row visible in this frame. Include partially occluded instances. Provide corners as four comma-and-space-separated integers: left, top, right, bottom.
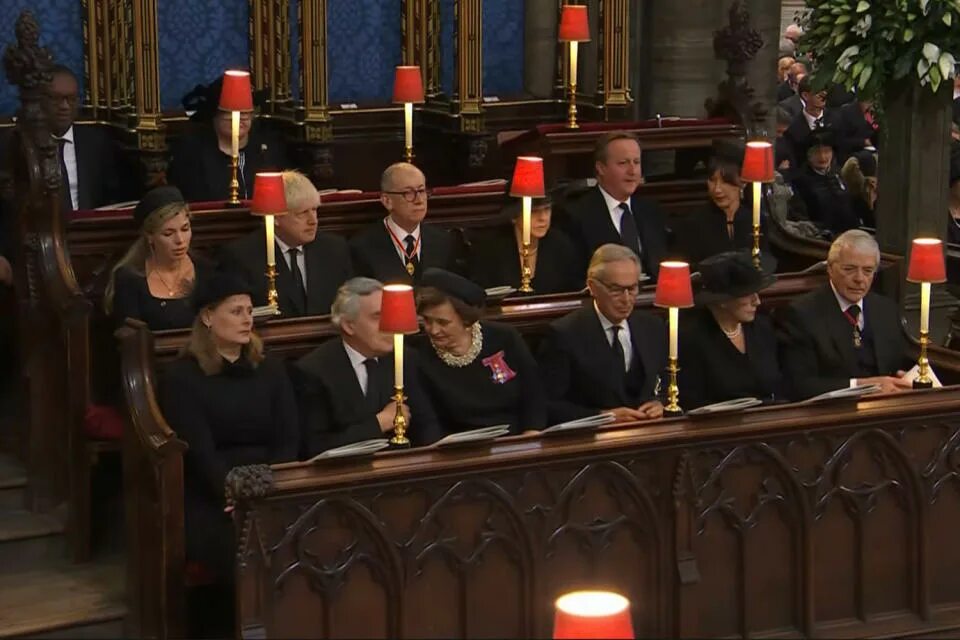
560, 187, 667, 281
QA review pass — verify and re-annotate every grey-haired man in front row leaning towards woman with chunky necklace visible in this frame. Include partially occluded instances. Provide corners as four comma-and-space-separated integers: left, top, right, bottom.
294, 278, 441, 457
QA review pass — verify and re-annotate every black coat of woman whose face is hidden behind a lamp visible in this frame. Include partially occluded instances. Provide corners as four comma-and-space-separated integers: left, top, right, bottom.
468, 225, 585, 294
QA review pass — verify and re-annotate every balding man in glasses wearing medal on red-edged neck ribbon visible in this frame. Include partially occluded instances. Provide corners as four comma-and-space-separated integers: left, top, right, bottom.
350, 162, 454, 284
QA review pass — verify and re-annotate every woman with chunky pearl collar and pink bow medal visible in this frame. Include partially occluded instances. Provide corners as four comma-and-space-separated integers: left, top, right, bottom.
415, 269, 547, 433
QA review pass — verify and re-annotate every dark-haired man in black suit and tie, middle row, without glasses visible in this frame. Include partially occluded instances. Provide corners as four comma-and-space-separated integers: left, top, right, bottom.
560, 131, 667, 281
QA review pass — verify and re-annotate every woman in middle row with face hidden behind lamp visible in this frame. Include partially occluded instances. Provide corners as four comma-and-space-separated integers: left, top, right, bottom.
468, 189, 584, 293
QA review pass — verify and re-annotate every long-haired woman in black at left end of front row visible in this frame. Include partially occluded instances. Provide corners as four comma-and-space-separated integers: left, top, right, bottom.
160, 272, 299, 632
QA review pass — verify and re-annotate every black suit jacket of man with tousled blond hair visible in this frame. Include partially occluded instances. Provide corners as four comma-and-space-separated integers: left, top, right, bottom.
220, 228, 353, 317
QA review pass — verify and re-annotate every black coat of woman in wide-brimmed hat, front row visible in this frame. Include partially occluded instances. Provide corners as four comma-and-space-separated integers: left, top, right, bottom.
679, 309, 785, 409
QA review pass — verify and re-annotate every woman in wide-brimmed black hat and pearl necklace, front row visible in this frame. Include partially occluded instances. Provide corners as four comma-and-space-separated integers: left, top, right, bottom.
679, 252, 783, 409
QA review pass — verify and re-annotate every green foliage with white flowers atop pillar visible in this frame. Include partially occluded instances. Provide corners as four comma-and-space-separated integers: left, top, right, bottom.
800, 0, 960, 101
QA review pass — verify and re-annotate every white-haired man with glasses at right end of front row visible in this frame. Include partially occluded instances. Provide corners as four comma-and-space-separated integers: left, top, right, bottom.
778, 229, 911, 399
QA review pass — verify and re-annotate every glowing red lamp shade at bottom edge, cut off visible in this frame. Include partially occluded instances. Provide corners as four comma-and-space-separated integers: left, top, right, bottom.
553, 591, 634, 639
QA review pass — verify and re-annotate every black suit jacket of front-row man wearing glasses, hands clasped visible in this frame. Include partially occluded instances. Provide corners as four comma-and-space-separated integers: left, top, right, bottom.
539, 304, 667, 423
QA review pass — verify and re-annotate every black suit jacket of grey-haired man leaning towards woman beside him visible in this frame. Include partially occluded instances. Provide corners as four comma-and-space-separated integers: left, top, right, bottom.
295, 339, 441, 458
